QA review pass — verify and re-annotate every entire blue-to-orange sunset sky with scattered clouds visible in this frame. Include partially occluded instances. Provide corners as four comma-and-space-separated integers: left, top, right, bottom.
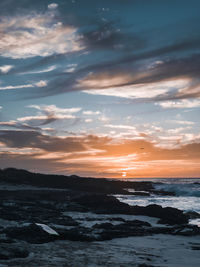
0, 0, 200, 178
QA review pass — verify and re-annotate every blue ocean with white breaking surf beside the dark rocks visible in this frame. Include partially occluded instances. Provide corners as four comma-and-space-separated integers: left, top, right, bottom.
117, 178, 200, 227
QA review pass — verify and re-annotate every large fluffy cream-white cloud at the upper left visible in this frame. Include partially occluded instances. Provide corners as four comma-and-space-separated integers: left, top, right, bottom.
0, 7, 83, 59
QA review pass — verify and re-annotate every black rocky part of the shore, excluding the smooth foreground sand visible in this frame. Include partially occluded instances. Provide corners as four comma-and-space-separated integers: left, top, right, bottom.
0, 169, 200, 266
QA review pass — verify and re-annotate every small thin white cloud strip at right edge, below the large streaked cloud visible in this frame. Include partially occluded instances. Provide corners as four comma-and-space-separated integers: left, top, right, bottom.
155, 99, 200, 109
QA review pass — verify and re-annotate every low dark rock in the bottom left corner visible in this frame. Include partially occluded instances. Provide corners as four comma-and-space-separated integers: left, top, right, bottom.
0, 244, 29, 260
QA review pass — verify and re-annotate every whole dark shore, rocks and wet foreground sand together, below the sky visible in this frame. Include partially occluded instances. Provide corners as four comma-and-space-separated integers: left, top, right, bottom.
0, 170, 200, 267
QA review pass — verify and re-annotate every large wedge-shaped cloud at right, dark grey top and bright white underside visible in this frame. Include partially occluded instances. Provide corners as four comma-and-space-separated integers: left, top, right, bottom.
33, 45, 200, 102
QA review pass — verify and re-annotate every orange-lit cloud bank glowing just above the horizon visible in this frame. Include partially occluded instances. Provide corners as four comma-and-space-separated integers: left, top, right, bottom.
0, 130, 200, 177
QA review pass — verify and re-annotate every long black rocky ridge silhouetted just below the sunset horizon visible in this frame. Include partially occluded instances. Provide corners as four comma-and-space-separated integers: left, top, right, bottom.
0, 168, 172, 195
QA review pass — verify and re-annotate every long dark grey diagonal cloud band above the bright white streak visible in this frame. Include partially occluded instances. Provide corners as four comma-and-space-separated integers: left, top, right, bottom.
25, 40, 200, 98
